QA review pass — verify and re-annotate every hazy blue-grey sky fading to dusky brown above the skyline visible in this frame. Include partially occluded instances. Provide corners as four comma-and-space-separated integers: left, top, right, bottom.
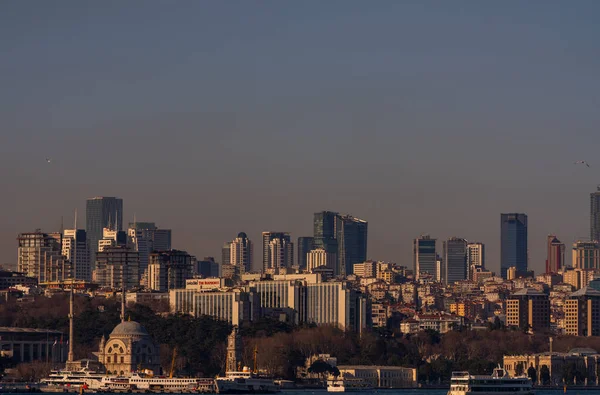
0, 0, 600, 272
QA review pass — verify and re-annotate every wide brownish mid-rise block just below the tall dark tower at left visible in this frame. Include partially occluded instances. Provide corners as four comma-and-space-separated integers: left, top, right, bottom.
92, 246, 140, 289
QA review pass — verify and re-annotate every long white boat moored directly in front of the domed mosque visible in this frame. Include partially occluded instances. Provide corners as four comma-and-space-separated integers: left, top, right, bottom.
88, 373, 215, 392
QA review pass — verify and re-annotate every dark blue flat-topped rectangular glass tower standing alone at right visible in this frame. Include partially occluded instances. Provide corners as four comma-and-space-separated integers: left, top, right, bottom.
500, 213, 527, 279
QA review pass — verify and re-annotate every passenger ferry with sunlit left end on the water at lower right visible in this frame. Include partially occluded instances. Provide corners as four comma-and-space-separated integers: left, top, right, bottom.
448, 368, 535, 395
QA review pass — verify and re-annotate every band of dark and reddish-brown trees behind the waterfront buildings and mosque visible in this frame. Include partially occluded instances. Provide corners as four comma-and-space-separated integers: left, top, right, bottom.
0, 295, 600, 383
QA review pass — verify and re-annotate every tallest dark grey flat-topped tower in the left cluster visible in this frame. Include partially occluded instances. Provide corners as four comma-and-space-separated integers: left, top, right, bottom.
85, 197, 123, 268
